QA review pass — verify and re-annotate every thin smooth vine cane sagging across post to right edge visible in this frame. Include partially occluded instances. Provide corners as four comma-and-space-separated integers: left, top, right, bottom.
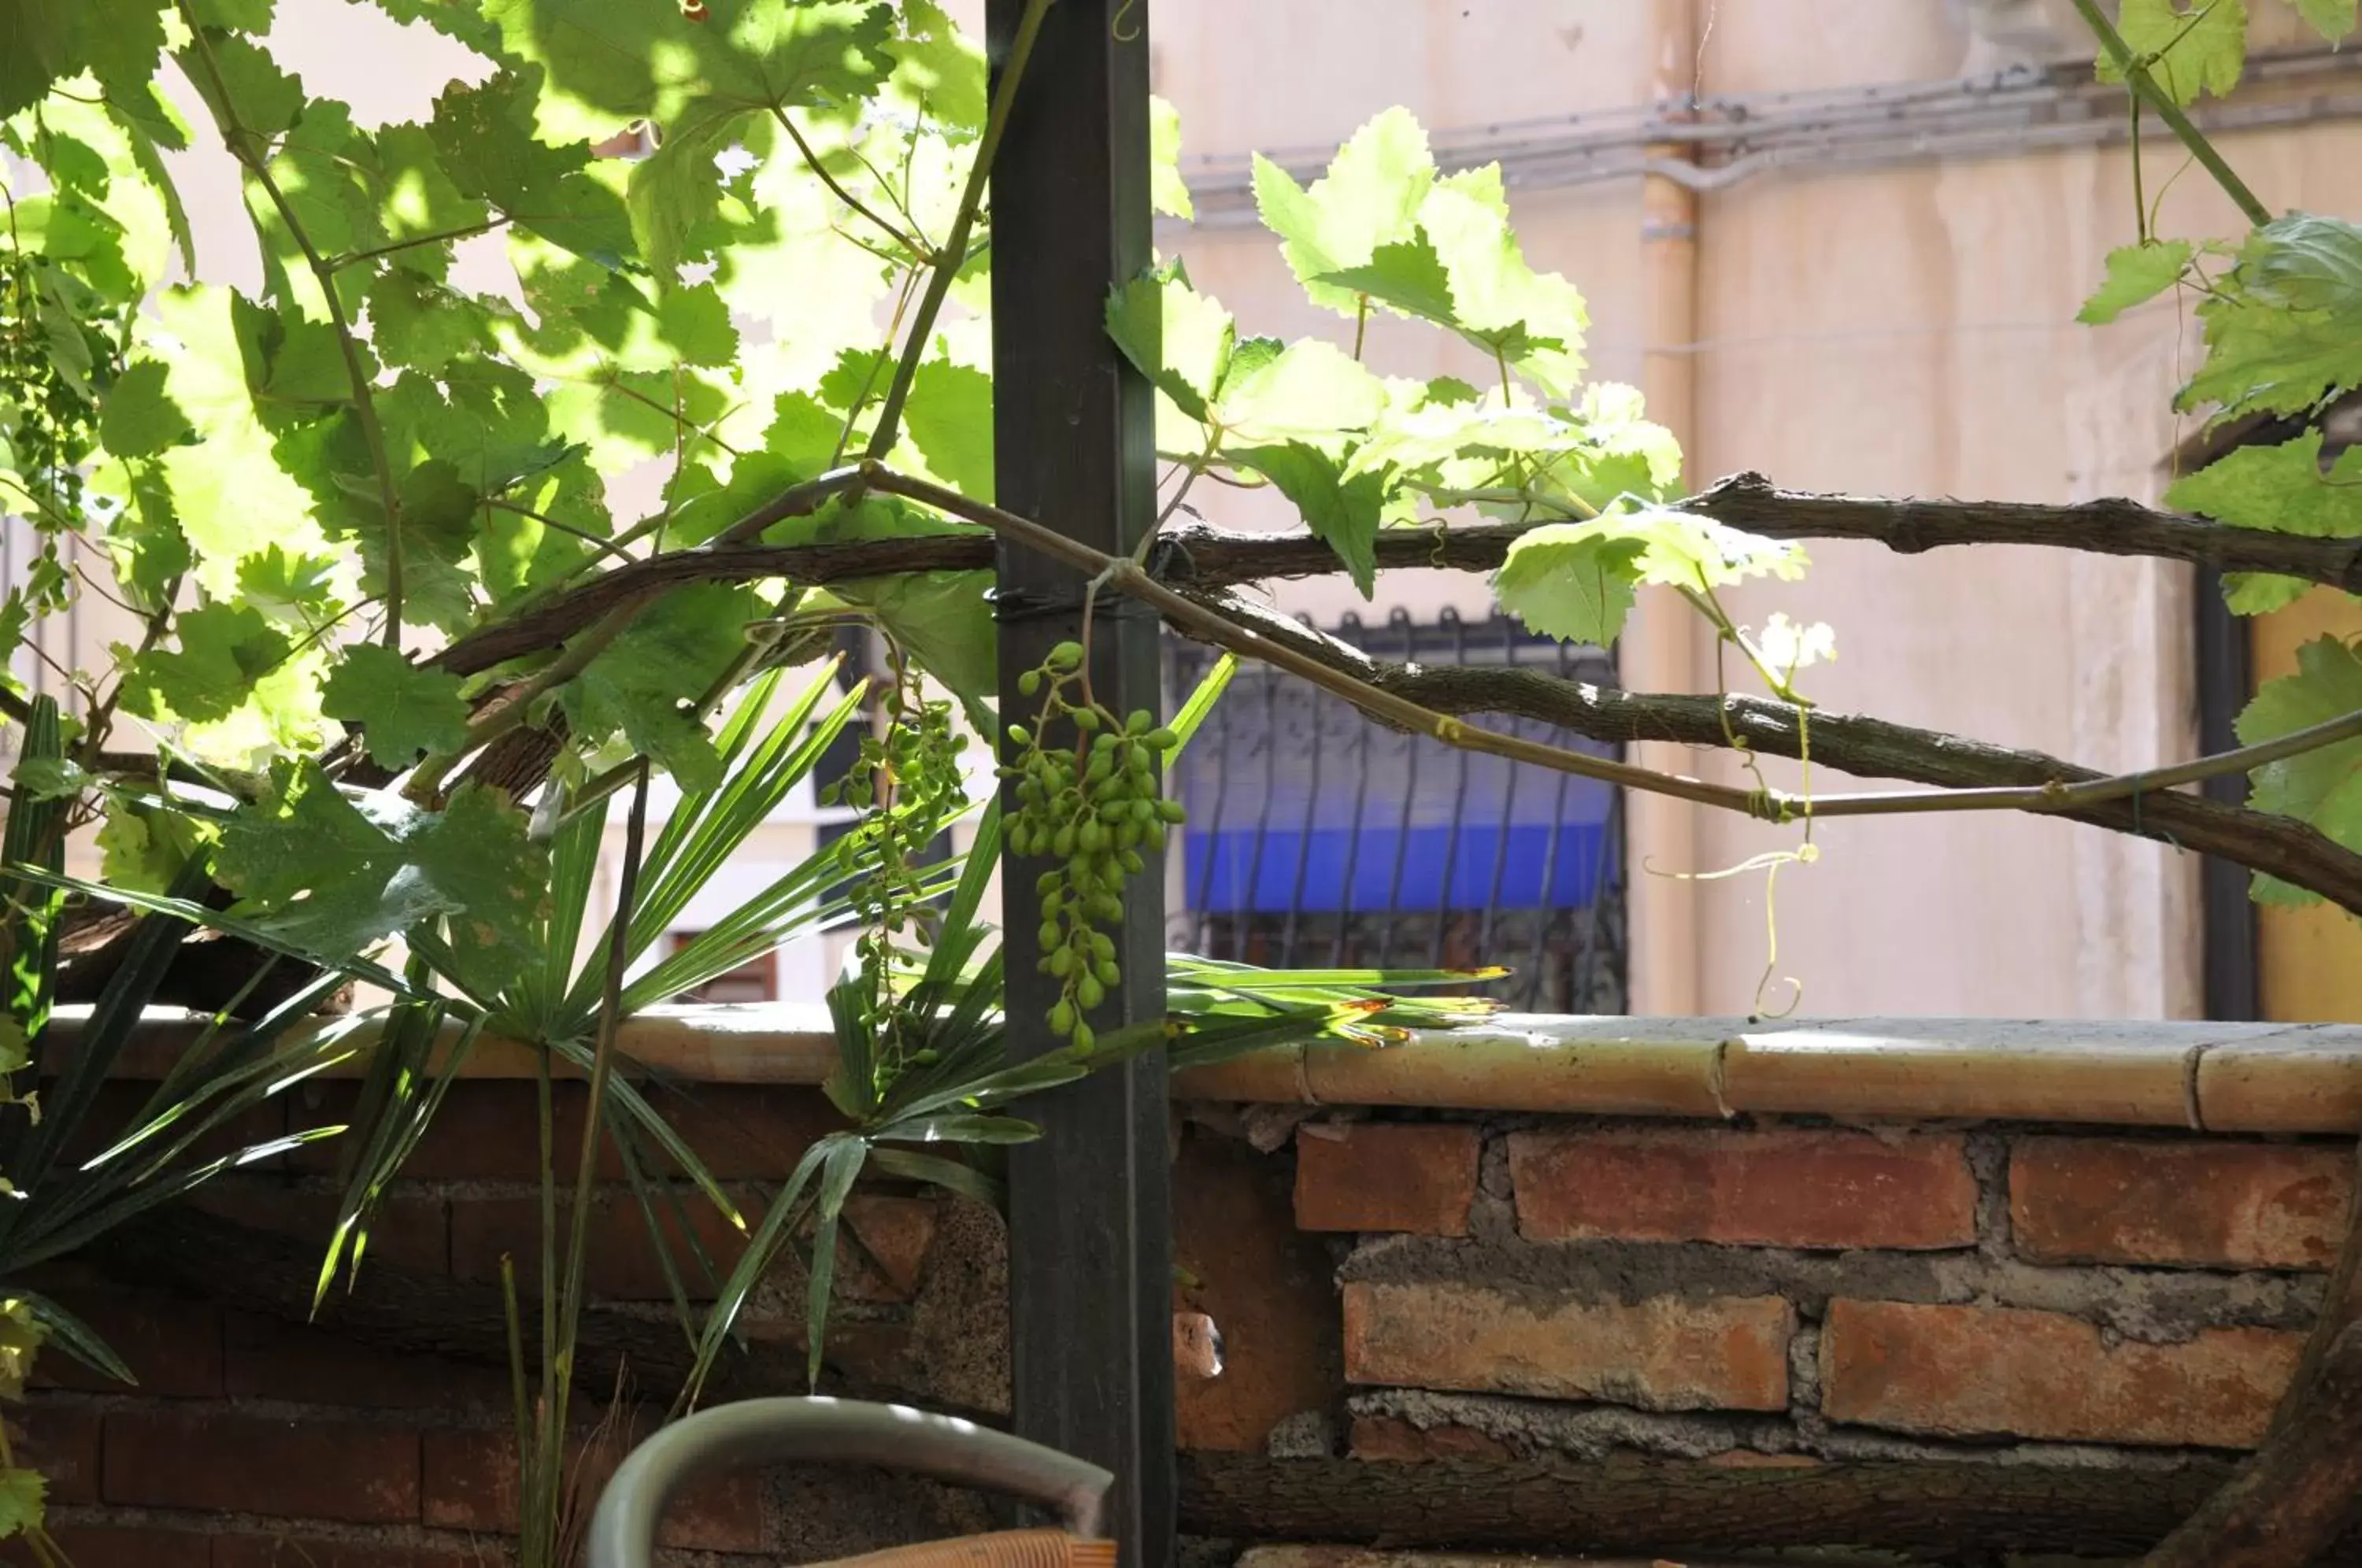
822, 463, 2362, 822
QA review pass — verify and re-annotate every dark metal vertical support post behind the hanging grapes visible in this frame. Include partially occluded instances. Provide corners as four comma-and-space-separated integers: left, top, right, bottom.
985, 0, 1174, 1568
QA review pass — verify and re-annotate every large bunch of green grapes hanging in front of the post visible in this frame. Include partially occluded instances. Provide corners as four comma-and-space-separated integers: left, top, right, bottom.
1001, 642, 1183, 1051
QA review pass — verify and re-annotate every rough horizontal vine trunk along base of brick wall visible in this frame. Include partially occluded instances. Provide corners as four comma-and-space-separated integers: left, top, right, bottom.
1181, 1455, 2362, 1561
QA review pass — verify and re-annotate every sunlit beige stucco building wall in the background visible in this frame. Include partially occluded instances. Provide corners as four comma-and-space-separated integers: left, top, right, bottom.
1157, 0, 2362, 1018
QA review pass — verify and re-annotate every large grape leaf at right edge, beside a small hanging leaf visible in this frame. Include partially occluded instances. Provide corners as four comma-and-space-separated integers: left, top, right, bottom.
2175, 213, 2362, 418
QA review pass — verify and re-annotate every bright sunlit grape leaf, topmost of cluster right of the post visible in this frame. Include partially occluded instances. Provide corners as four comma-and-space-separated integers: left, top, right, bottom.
1254, 109, 1436, 316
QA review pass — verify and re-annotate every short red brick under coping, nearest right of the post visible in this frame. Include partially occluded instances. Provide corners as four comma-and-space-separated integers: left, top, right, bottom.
1297, 1122, 1476, 1235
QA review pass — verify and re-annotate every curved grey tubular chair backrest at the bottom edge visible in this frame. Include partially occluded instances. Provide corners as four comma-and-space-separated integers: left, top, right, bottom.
586, 1398, 1115, 1568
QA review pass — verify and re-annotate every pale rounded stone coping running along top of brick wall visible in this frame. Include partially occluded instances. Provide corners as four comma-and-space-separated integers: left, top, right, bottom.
54, 1004, 2362, 1133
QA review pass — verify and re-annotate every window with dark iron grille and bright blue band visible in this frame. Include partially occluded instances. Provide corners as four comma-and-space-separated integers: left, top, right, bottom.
1167, 609, 1625, 1013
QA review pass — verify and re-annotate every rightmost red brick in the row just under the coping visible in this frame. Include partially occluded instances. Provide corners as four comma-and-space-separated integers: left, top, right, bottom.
2010, 1138, 2355, 1268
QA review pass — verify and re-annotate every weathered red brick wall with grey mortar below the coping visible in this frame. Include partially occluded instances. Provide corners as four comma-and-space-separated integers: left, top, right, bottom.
0, 1084, 2353, 1568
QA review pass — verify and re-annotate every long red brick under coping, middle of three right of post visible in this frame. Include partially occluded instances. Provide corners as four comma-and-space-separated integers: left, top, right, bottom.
1509, 1129, 1977, 1249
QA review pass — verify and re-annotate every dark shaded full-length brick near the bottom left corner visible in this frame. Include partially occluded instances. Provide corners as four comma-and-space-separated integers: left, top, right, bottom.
99, 1410, 418, 1523
